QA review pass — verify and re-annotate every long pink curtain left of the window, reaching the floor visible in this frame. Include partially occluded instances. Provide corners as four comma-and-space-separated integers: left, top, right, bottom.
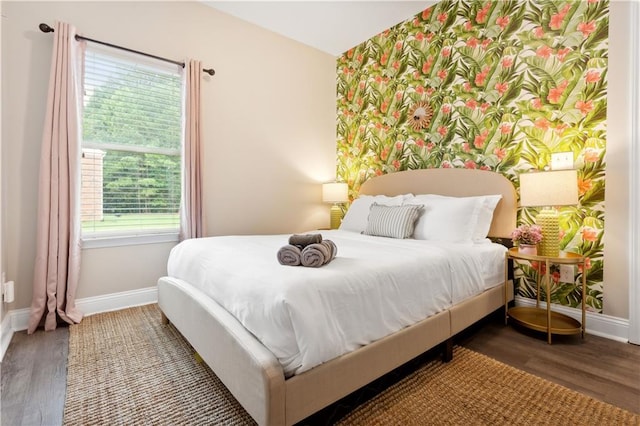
27, 22, 83, 334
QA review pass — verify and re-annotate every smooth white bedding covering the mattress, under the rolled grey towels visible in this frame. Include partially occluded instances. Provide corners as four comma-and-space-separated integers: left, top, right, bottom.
168, 230, 505, 376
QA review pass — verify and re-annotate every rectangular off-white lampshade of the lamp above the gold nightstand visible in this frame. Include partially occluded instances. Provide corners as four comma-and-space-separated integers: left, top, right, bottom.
520, 170, 578, 207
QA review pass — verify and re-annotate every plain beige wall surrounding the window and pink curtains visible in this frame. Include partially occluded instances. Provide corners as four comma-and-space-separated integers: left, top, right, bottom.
2, 2, 336, 309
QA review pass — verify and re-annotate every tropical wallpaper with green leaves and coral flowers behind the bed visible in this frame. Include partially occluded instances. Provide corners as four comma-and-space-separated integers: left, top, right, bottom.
337, 0, 609, 312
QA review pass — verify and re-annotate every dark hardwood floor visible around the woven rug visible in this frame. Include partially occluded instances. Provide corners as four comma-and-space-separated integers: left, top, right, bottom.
0, 311, 640, 426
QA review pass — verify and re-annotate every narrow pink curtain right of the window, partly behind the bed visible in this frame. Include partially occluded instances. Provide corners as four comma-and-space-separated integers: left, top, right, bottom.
180, 60, 204, 241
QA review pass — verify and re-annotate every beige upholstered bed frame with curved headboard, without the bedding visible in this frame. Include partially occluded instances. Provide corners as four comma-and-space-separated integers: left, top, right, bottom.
158, 169, 517, 425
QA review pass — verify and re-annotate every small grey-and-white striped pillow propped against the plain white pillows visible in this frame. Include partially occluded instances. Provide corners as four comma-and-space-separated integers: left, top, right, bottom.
363, 203, 422, 238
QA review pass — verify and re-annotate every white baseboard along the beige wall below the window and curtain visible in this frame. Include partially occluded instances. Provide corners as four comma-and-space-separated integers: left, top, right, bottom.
0, 286, 158, 361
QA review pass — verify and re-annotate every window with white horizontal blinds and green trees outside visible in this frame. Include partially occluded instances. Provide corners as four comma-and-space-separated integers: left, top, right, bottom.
81, 45, 182, 245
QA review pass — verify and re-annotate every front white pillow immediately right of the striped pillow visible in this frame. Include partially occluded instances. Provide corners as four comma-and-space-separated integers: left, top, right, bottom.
406, 194, 482, 243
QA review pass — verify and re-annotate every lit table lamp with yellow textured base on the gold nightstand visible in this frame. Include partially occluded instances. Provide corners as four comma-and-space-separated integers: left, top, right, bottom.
520, 170, 578, 257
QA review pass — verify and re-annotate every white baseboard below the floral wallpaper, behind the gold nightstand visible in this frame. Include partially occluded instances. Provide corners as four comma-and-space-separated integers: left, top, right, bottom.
516, 296, 629, 343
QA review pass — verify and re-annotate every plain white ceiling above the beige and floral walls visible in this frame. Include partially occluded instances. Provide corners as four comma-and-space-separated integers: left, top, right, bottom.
203, 0, 436, 56
